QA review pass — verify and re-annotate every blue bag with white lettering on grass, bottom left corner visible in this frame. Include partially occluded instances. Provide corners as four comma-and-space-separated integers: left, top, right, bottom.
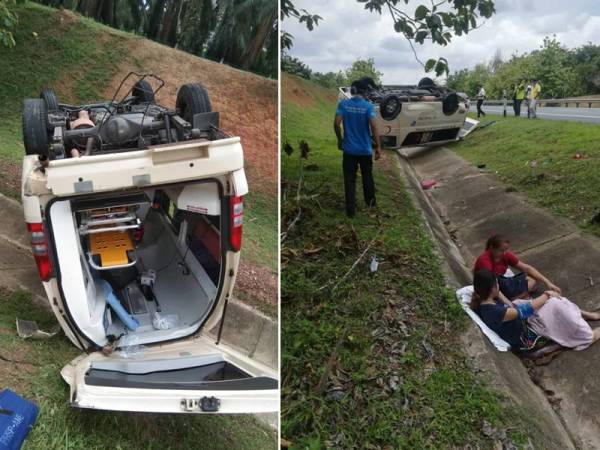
0, 389, 38, 450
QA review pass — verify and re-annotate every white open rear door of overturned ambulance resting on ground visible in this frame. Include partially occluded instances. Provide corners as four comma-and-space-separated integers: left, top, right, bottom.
61, 335, 279, 413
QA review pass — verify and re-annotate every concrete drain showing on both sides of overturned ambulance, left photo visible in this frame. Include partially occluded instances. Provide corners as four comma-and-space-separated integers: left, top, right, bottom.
0, 194, 278, 428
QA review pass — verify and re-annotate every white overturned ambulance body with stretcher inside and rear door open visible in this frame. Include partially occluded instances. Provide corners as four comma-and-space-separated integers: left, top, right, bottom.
22, 137, 279, 413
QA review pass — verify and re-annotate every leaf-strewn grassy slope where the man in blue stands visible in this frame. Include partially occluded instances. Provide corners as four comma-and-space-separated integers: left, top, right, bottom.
281, 76, 525, 449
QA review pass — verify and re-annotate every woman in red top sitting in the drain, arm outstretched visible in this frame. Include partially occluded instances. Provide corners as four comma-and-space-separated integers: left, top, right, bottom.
473, 234, 561, 300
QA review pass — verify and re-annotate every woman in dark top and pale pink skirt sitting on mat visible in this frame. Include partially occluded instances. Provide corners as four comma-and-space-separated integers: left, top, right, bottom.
470, 269, 600, 350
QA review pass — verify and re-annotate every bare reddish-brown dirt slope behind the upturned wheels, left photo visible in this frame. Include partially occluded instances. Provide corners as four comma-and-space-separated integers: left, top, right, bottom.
104, 39, 278, 195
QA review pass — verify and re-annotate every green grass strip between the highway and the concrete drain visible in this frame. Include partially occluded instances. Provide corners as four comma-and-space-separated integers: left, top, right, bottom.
450, 115, 600, 235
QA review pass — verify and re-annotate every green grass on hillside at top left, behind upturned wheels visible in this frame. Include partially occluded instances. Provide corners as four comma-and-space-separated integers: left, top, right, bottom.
0, 3, 129, 161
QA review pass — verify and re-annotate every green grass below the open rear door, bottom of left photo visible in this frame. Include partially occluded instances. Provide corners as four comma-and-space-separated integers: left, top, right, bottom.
0, 292, 277, 450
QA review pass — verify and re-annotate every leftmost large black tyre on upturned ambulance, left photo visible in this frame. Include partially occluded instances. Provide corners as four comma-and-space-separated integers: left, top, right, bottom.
23, 98, 48, 156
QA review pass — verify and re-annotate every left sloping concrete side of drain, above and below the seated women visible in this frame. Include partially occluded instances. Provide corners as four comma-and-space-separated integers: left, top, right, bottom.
398, 149, 576, 449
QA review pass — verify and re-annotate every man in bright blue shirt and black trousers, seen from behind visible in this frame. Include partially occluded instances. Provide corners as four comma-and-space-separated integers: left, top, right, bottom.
333, 79, 381, 217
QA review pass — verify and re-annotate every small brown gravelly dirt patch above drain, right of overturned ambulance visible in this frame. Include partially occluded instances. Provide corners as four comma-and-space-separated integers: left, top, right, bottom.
235, 261, 277, 307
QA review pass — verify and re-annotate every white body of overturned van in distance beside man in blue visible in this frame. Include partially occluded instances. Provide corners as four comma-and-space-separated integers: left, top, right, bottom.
338, 86, 469, 149
